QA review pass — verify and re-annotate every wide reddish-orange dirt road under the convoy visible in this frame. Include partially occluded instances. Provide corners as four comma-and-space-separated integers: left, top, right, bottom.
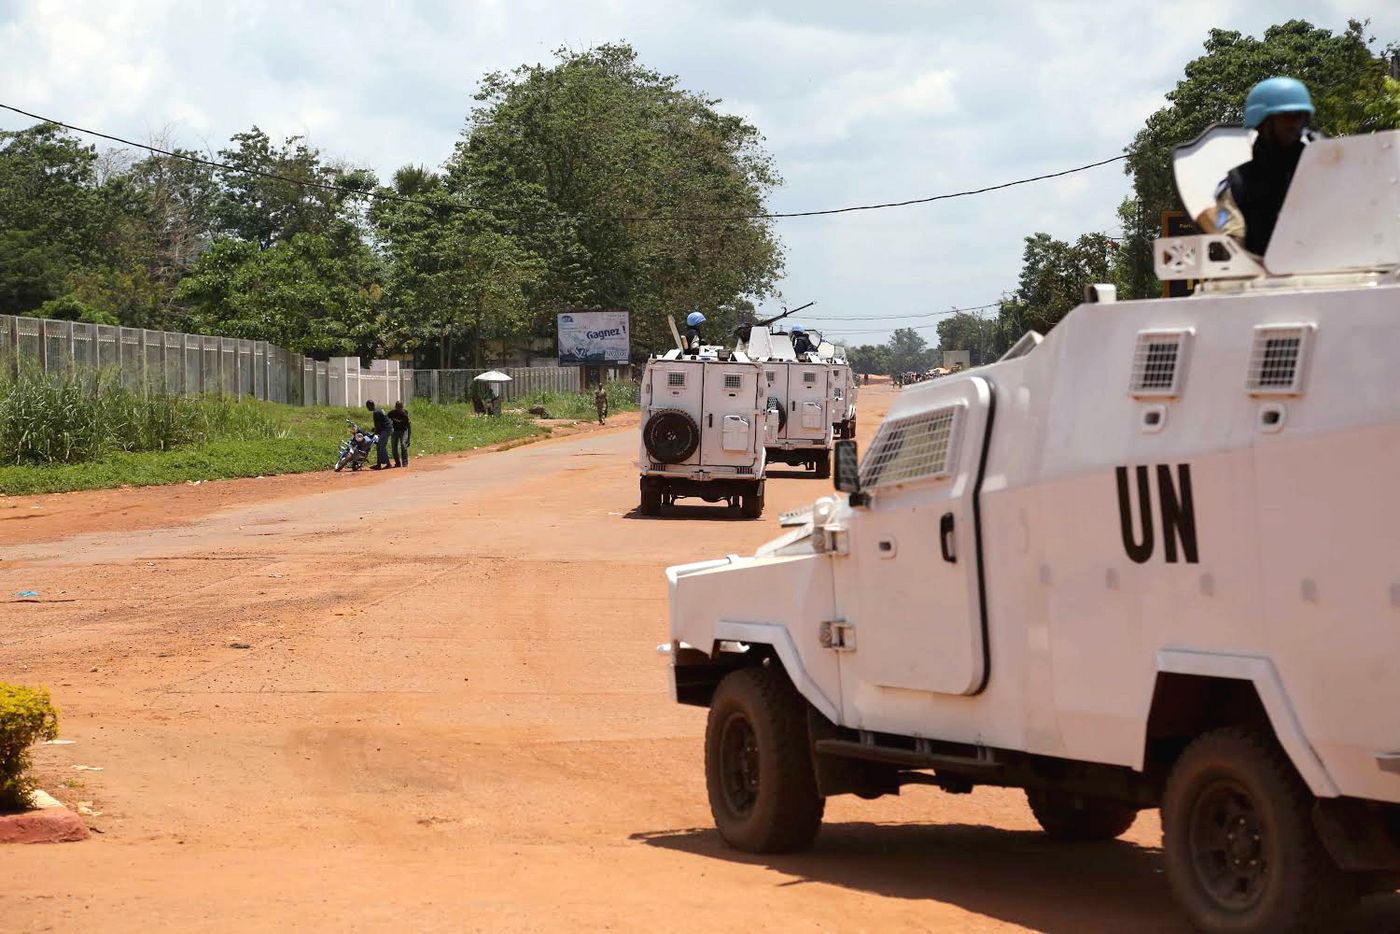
0, 386, 1397, 931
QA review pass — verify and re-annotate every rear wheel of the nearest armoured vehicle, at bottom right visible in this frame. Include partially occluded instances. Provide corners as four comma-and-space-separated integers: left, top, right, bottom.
1162, 727, 1357, 931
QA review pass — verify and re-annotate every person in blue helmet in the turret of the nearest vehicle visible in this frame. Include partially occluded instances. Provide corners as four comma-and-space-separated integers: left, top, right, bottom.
1197, 77, 1315, 256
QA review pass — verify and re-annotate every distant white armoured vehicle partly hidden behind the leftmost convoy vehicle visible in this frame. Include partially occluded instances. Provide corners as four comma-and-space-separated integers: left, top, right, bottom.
738, 326, 848, 479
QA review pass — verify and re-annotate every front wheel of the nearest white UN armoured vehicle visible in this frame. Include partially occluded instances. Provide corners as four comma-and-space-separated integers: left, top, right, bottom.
704, 668, 826, 853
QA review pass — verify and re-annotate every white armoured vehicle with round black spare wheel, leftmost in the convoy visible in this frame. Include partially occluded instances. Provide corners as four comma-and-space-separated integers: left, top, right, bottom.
638, 347, 771, 518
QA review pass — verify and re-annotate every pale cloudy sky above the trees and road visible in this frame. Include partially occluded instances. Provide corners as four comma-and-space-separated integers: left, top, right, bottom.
0, 0, 1400, 343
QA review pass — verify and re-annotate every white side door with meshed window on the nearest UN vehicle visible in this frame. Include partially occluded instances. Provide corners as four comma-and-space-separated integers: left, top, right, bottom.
834, 377, 991, 732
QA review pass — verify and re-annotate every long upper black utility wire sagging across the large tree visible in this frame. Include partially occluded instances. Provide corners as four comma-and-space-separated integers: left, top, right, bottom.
0, 102, 1127, 221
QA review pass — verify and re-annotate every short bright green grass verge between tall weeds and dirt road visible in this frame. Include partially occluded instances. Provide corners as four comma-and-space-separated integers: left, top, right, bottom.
0, 397, 545, 496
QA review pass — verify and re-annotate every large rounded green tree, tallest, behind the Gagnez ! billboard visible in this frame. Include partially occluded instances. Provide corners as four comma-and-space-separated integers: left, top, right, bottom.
445, 45, 781, 361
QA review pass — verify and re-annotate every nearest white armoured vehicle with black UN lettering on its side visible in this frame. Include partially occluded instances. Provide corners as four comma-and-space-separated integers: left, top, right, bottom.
666, 132, 1400, 931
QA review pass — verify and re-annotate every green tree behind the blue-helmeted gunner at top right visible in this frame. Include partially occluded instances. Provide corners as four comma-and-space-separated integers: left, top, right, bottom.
1120, 20, 1400, 298
